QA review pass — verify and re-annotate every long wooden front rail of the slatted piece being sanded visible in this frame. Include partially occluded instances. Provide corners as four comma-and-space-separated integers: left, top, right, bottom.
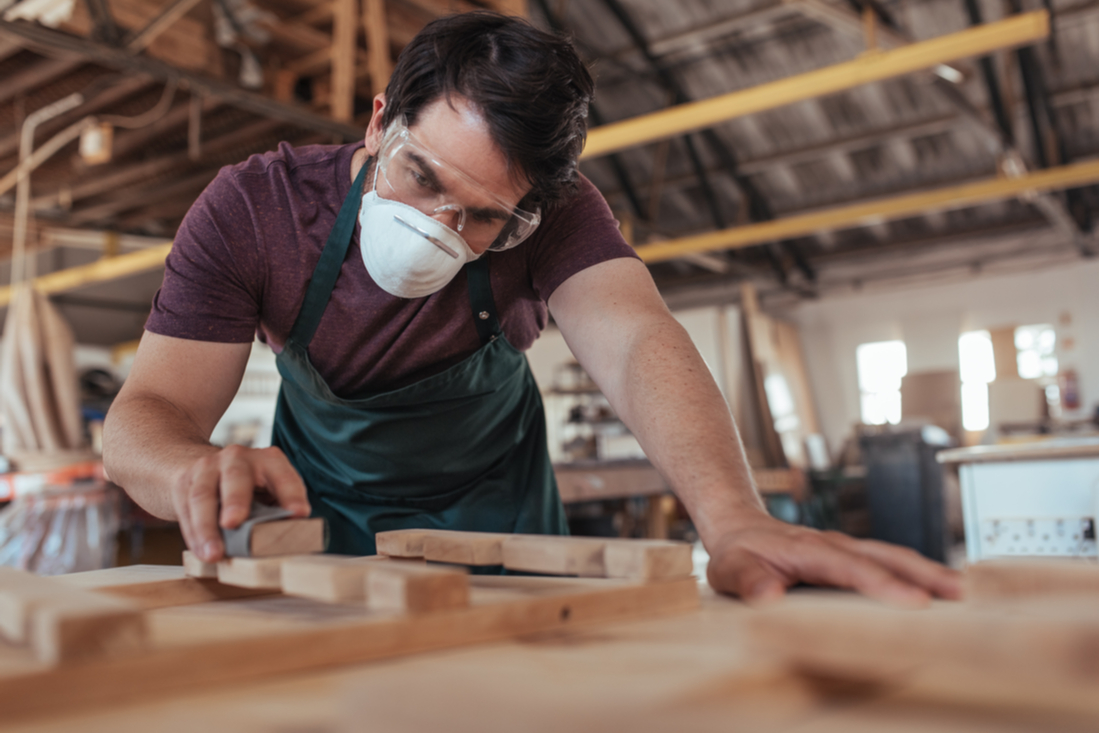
0, 577, 699, 723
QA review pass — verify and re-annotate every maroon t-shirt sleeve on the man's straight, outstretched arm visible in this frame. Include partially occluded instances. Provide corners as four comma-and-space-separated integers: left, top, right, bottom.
520, 176, 639, 302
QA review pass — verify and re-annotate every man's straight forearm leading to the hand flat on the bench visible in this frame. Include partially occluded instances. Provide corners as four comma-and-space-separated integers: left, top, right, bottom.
604, 318, 765, 546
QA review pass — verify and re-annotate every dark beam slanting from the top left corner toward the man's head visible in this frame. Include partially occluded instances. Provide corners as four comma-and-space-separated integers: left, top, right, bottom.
0, 20, 363, 142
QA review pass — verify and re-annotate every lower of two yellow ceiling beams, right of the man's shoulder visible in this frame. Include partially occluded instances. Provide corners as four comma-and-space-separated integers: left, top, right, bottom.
636, 161, 1100, 263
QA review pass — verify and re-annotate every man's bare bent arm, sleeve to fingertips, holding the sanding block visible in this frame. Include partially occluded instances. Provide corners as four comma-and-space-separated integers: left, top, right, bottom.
103, 331, 309, 561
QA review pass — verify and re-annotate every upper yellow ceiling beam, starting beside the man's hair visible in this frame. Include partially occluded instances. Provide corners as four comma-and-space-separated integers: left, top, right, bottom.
581, 11, 1051, 158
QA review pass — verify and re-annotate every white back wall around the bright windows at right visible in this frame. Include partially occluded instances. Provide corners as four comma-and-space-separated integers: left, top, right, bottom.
782, 260, 1100, 450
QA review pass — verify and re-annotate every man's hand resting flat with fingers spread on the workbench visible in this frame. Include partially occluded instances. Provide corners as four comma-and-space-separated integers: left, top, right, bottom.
706, 513, 963, 608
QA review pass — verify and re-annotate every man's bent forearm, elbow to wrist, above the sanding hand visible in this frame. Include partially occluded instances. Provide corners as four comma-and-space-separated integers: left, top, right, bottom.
103, 393, 218, 521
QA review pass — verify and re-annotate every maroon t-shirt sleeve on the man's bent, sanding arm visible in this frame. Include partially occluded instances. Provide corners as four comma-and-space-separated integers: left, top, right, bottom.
145, 168, 263, 343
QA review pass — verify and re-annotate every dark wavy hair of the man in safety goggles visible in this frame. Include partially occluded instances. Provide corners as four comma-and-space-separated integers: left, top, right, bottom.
382, 11, 593, 207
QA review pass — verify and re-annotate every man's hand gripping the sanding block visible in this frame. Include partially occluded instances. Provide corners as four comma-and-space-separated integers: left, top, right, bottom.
172, 446, 309, 562
